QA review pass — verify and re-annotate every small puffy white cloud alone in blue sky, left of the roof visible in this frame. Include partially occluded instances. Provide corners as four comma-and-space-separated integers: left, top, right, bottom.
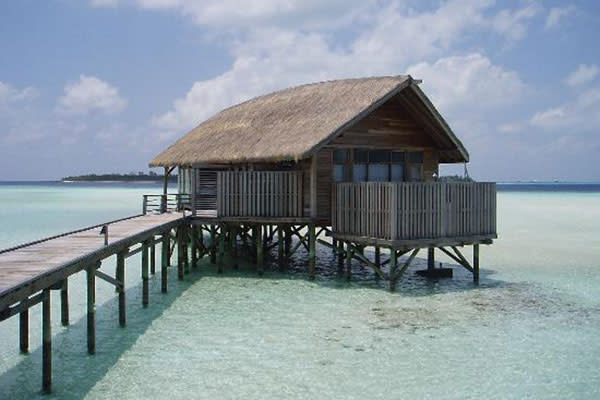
58, 75, 127, 114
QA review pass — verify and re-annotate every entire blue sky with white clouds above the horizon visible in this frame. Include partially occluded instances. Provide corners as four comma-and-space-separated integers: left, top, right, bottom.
0, 0, 600, 181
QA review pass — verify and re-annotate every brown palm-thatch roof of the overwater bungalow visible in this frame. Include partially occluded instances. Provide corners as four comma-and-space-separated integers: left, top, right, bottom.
150, 75, 469, 167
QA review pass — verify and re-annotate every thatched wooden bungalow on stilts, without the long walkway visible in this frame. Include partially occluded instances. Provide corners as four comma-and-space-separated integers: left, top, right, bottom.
150, 75, 496, 288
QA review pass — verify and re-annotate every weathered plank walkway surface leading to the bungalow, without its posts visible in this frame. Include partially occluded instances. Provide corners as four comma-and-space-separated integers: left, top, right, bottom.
0, 213, 183, 316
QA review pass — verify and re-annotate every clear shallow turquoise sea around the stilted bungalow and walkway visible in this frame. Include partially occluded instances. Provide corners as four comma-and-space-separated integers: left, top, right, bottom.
0, 182, 600, 400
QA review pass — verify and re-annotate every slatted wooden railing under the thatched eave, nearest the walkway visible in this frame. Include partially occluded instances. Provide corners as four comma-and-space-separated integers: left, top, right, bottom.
217, 171, 304, 218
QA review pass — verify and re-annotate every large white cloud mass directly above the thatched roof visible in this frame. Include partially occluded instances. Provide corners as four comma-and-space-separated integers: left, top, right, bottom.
153, 0, 534, 139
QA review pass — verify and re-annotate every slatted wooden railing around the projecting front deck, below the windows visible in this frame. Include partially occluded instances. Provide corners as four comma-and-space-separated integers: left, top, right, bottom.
332, 182, 496, 240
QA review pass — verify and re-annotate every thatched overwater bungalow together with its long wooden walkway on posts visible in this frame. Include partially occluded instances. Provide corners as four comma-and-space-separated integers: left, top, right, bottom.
0, 76, 496, 392
